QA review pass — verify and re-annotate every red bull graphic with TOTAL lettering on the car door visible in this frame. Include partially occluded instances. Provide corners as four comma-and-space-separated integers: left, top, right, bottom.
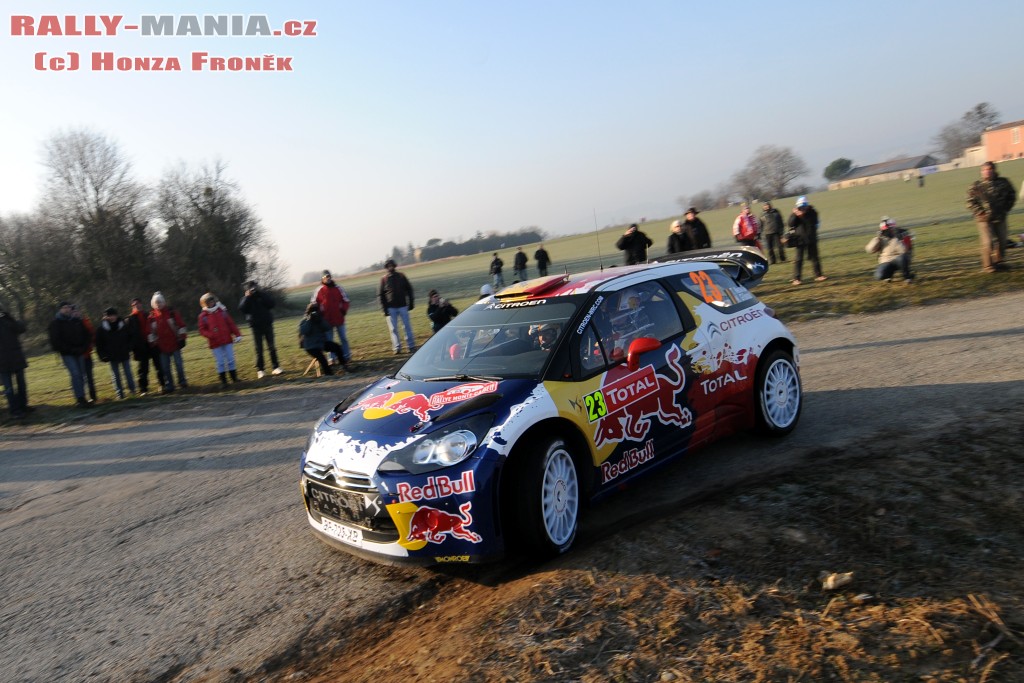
584, 346, 693, 447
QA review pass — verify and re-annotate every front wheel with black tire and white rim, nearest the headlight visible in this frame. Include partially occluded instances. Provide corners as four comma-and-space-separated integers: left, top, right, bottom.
510, 437, 583, 557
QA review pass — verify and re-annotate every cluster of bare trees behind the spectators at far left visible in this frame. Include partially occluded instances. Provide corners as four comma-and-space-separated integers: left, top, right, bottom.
0, 130, 282, 329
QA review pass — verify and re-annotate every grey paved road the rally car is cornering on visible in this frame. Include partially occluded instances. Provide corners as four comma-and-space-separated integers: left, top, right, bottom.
0, 295, 1024, 681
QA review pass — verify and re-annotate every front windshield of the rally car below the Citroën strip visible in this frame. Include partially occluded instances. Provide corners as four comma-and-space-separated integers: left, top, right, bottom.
396, 296, 585, 381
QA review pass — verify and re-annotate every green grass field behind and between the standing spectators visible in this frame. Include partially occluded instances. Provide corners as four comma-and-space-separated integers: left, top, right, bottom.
3, 160, 1024, 420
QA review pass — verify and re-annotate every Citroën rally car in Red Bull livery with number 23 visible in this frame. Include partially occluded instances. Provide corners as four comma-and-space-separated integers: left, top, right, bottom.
300, 248, 802, 564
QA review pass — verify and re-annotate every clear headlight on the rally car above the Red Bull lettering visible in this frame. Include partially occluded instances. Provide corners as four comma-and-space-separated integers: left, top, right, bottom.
377, 414, 495, 474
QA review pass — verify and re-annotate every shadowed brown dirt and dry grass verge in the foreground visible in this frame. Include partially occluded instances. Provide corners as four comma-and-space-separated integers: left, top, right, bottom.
268, 410, 1024, 682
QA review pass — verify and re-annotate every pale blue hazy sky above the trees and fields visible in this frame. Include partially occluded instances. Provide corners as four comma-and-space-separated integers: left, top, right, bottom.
0, 0, 1024, 284
